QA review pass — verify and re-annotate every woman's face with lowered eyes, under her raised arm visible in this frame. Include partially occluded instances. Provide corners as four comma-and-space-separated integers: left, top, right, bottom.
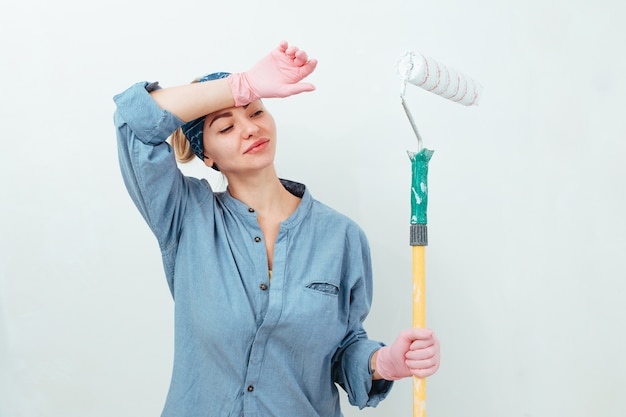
203, 100, 276, 175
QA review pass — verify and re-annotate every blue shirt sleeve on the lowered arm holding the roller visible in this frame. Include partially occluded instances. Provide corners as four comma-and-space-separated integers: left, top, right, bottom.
333, 229, 393, 409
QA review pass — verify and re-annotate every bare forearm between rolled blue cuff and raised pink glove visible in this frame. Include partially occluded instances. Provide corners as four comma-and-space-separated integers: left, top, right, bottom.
150, 78, 235, 122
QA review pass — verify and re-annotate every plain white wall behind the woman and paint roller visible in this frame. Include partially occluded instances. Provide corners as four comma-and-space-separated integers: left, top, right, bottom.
0, 0, 626, 417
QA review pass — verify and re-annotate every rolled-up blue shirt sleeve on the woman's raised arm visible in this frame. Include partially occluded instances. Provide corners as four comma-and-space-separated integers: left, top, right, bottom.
113, 82, 210, 290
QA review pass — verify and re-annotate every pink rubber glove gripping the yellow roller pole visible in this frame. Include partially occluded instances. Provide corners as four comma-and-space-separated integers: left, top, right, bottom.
376, 328, 439, 381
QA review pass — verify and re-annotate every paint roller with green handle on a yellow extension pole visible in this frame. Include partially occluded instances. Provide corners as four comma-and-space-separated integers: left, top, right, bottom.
398, 52, 482, 417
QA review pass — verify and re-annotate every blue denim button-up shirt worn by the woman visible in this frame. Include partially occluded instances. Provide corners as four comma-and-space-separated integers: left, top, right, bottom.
114, 82, 392, 417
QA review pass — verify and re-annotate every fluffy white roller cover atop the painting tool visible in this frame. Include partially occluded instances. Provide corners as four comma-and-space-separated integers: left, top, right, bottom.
398, 52, 482, 106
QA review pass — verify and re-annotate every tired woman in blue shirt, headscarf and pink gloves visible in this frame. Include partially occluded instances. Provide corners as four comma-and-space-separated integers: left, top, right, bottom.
115, 42, 439, 417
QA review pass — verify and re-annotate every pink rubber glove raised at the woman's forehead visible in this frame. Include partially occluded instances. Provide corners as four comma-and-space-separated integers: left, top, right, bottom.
227, 41, 317, 106
